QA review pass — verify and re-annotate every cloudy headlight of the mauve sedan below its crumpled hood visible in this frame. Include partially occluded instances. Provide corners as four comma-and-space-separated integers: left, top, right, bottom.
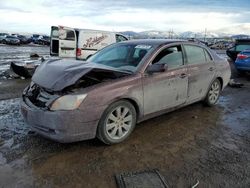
50, 94, 87, 111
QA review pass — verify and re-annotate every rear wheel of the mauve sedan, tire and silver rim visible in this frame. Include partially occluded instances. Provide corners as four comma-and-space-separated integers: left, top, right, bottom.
204, 79, 221, 106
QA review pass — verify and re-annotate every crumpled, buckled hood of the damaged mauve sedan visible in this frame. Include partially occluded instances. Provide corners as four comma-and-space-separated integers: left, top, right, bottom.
32, 59, 124, 91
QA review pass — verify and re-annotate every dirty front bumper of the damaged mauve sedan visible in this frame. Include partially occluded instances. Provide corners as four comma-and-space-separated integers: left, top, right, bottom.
21, 97, 102, 143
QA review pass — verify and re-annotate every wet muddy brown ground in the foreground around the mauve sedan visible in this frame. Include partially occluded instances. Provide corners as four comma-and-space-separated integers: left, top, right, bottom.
0, 51, 250, 188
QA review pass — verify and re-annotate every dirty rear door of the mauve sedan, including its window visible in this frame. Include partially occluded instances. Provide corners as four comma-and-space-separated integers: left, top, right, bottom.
184, 44, 215, 102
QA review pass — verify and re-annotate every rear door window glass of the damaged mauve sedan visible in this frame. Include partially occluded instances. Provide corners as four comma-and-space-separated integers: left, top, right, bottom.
184, 45, 207, 65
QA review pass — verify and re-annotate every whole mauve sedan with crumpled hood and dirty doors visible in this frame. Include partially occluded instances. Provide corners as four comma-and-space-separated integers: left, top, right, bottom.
21, 40, 231, 144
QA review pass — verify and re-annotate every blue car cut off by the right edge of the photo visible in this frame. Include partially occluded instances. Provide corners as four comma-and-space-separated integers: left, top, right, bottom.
235, 49, 250, 73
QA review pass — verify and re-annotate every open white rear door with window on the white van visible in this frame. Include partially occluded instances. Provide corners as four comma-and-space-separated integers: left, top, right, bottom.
59, 26, 77, 58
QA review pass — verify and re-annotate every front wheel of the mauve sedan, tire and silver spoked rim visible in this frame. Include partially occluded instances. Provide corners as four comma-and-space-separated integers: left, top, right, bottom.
97, 100, 136, 145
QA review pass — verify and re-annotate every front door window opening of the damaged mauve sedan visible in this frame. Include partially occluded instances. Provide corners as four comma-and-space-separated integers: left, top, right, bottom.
152, 45, 183, 69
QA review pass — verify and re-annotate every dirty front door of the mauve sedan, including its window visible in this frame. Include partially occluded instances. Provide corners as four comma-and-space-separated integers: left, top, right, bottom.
143, 45, 188, 115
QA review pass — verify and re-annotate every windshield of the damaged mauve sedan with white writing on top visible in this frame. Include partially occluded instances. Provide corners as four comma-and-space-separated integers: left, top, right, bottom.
87, 44, 153, 72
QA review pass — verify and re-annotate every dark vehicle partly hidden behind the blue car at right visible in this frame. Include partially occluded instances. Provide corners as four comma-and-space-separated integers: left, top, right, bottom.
227, 39, 250, 61
